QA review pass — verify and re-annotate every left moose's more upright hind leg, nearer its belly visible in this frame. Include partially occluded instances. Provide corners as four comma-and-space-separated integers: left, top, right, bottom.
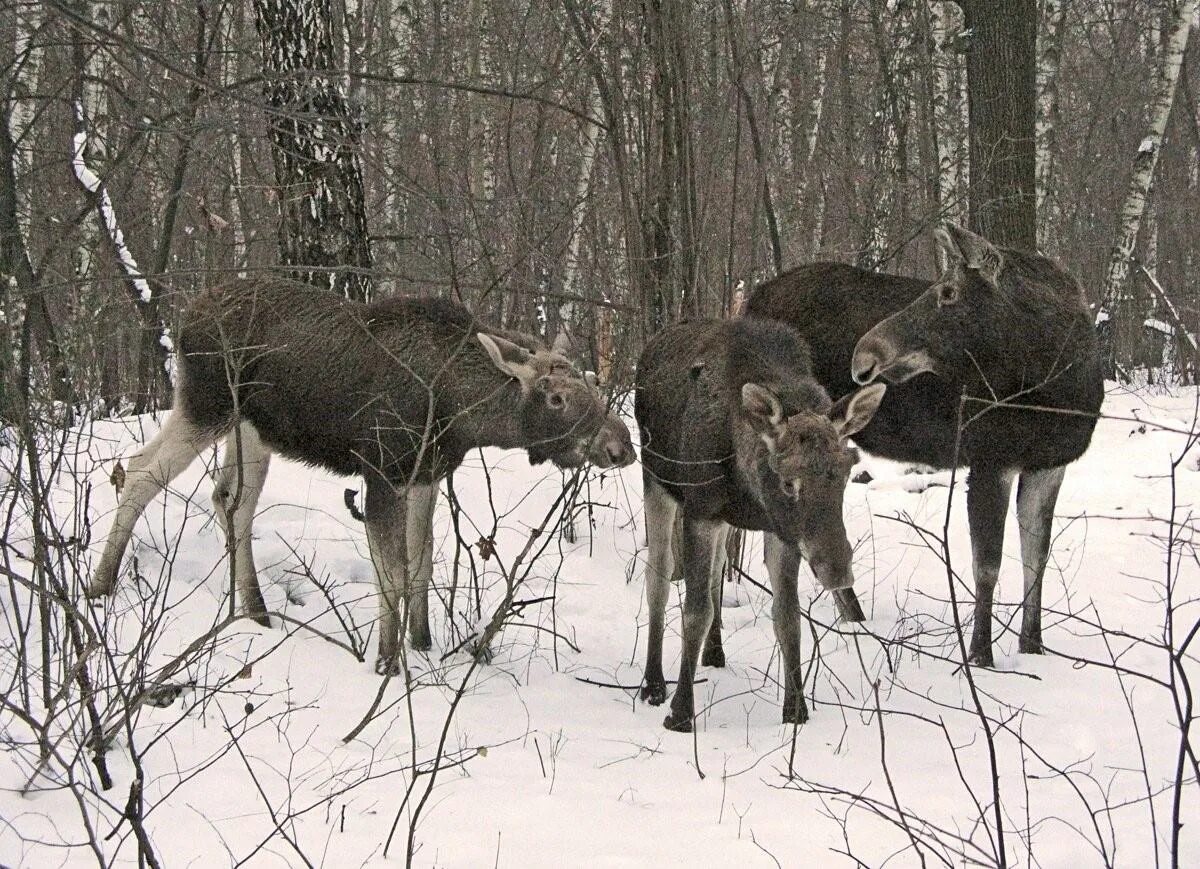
212, 422, 271, 628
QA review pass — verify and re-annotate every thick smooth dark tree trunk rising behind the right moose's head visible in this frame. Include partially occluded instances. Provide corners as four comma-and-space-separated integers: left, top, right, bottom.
956, 0, 1038, 251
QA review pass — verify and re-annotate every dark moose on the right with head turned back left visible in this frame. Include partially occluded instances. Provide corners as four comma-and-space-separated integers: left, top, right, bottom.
746, 226, 1104, 666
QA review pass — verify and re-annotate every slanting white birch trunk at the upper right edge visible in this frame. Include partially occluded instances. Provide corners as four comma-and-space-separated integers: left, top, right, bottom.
1097, 0, 1196, 364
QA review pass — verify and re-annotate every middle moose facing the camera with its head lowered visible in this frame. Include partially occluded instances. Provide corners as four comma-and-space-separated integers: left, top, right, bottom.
634, 319, 887, 732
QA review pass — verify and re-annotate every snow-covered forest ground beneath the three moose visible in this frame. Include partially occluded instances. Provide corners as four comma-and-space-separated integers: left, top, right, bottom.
0, 389, 1200, 868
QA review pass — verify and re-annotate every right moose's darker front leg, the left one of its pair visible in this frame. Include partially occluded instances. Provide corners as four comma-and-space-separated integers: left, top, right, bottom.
967, 468, 1013, 667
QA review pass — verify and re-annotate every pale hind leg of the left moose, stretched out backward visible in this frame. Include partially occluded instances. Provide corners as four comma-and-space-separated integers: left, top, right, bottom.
86, 410, 218, 598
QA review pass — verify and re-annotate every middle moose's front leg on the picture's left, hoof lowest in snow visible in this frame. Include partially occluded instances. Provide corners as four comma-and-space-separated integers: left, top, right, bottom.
662, 516, 725, 733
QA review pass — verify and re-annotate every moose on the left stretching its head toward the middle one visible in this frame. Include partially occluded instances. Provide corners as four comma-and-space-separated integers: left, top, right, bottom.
88, 277, 606, 672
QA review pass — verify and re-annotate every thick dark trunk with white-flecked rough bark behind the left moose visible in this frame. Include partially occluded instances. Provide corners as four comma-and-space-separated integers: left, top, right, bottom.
254, 0, 371, 301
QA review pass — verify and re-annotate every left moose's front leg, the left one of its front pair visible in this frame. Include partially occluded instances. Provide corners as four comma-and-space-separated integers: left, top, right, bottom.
365, 478, 408, 676
